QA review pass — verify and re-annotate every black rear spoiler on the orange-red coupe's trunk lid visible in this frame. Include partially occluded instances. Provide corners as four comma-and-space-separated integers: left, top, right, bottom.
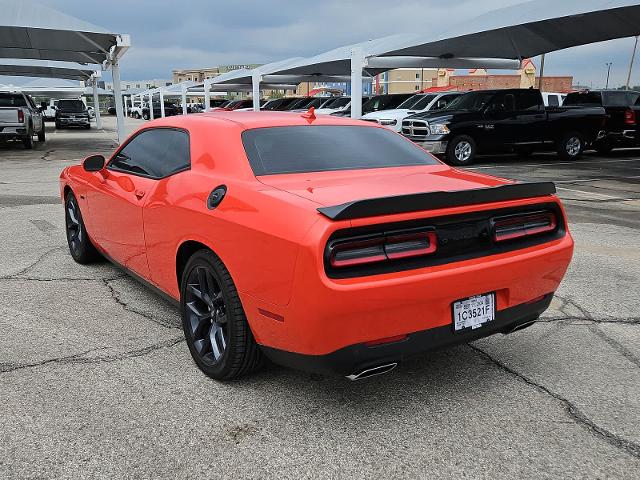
318, 182, 556, 220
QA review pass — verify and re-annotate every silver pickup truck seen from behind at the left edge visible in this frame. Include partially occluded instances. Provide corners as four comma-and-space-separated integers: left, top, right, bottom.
0, 92, 45, 149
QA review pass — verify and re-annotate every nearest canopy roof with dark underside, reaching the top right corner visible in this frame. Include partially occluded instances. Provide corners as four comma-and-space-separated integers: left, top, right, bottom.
381, 0, 640, 59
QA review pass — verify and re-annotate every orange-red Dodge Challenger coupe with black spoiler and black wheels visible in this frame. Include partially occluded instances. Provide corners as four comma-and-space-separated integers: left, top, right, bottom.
60, 112, 573, 379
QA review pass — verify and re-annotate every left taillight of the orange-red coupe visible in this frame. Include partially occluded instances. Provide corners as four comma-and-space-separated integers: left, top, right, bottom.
329, 231, 438, 268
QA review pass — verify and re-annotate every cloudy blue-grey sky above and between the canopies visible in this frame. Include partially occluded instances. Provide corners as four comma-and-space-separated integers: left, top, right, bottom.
5, 0, 640, 87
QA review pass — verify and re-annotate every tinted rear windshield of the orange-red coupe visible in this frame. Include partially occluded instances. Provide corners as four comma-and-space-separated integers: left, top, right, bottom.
242, 125, 438, 175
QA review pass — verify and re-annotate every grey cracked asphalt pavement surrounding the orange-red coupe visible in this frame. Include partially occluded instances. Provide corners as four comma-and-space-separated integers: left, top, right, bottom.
0, 117, 640, 479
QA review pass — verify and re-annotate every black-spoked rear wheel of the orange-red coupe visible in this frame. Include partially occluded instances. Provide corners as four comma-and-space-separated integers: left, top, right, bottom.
180, 250, 262, 380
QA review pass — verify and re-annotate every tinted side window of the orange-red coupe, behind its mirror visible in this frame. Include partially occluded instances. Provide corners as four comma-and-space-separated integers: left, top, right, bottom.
109, 128, 191, 178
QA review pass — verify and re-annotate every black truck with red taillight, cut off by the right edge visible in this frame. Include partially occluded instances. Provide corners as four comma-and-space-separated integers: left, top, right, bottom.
564, 90, 640, 155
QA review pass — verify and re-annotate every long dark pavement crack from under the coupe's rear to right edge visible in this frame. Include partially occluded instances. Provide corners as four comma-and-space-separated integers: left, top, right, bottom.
468, 344, 640, 459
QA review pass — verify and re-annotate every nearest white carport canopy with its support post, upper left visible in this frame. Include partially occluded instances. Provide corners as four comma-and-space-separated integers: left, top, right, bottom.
0, 0, 131, 141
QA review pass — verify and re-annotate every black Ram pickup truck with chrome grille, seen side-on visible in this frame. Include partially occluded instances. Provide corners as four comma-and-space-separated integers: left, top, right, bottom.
402, 89, 605, 165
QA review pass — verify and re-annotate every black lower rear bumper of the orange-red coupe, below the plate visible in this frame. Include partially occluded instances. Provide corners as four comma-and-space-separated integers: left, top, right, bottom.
262, 293, 553, 375
